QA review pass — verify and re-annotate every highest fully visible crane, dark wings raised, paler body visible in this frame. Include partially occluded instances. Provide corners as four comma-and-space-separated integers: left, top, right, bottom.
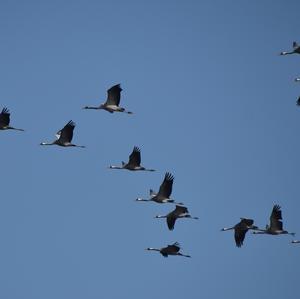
83, 84, 133, 114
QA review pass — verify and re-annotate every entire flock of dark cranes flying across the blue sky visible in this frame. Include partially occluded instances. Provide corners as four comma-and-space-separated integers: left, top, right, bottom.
0, 42, 300, 257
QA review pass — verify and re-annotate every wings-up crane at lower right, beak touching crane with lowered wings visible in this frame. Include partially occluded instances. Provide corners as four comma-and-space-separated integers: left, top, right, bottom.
253, 204, 295, 236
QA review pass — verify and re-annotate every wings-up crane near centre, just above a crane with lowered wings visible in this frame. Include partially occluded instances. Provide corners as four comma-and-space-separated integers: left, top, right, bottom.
136, 172, 183, 205
